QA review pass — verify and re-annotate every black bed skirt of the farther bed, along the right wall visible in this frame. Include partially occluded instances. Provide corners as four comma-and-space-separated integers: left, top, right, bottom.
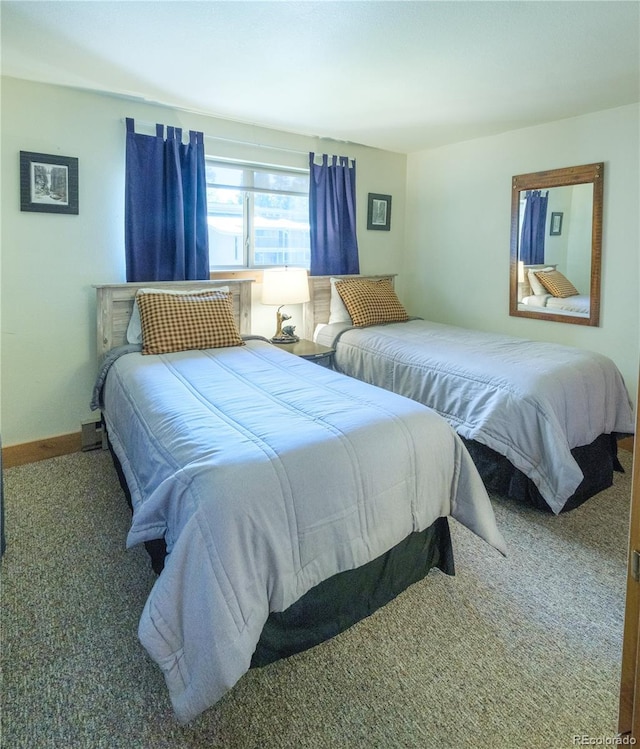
462, 434, 624, 512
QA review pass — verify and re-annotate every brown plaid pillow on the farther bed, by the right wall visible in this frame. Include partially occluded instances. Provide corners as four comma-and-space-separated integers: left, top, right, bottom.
336, 278, 409, 328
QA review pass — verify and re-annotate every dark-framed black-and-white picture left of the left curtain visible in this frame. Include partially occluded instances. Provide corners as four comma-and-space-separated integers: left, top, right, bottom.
20, 151, 78, 214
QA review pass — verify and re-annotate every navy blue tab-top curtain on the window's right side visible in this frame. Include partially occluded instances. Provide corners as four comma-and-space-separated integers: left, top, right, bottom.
309, 153, 360, 276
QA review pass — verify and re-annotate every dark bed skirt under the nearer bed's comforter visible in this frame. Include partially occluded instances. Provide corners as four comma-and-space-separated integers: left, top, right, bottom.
108, 432, 455, 668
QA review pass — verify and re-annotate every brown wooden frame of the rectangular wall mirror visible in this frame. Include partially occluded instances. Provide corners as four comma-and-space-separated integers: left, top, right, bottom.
509, 162, 604, 326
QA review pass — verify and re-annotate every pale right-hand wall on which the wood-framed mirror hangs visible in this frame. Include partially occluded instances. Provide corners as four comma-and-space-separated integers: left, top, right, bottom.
402, 105, 640, 402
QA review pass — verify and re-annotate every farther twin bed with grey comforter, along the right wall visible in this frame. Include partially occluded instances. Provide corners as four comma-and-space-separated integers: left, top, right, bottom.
306, 276, 634, 513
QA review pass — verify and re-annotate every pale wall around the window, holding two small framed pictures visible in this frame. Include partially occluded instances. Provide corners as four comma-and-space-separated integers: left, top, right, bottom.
0, 78, 406, 446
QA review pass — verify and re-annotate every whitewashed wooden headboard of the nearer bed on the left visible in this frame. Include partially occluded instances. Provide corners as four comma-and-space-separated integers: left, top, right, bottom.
95, 279, 253, 361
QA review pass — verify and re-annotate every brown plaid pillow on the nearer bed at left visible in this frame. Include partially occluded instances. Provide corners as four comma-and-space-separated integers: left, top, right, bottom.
136, 290, 244, 354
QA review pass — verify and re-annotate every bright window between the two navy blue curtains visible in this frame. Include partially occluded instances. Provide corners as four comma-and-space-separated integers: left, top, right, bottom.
206, 159, 309, 268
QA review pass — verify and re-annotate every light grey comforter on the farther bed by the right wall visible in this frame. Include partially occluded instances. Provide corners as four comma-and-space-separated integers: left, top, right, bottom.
317, 320, 634, 513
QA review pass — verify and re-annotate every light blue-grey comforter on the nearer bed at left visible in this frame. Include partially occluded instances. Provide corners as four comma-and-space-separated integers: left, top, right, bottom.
96, 341, 504, 721
